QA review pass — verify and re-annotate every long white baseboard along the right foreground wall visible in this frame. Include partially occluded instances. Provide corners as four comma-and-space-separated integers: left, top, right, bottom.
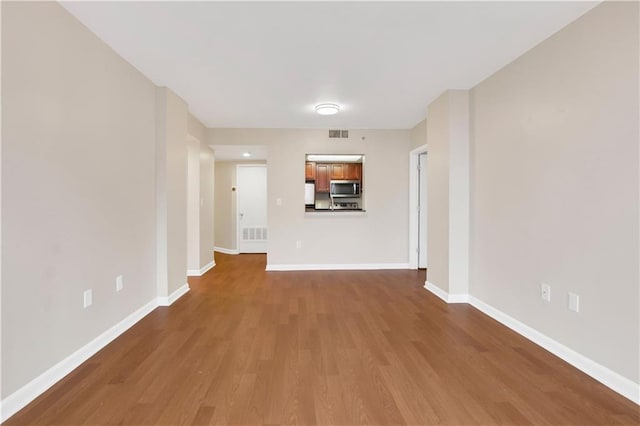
469, 296, 640, 405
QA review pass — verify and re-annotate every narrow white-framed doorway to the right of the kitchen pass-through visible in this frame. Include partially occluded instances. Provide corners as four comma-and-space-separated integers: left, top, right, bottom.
409, 145, 428, 269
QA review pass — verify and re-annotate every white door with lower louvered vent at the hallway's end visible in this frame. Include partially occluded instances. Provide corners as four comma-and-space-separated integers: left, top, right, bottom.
236, 164, 267, 253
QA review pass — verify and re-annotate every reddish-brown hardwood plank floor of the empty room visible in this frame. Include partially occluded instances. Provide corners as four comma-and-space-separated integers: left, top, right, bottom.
6, 253, 640, 425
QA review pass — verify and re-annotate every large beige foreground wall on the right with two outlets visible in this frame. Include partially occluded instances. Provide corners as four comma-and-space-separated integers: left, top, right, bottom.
468, 2, 640, 383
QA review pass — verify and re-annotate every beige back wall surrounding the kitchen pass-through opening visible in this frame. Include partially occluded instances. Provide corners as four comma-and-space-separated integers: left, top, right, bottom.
208, 129, 410, 265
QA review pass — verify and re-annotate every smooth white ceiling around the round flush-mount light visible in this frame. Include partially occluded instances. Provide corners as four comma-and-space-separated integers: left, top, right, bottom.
62, 1, 597, 129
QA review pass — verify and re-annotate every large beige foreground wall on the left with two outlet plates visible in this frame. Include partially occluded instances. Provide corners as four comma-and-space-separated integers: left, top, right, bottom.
2, 2, 156, 398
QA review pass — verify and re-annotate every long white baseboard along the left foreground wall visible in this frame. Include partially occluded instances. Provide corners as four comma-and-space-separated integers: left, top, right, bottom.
0, 299, 158, 422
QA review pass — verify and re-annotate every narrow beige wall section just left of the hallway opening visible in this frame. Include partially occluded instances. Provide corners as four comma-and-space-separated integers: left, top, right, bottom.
200, 143, 215, 268
